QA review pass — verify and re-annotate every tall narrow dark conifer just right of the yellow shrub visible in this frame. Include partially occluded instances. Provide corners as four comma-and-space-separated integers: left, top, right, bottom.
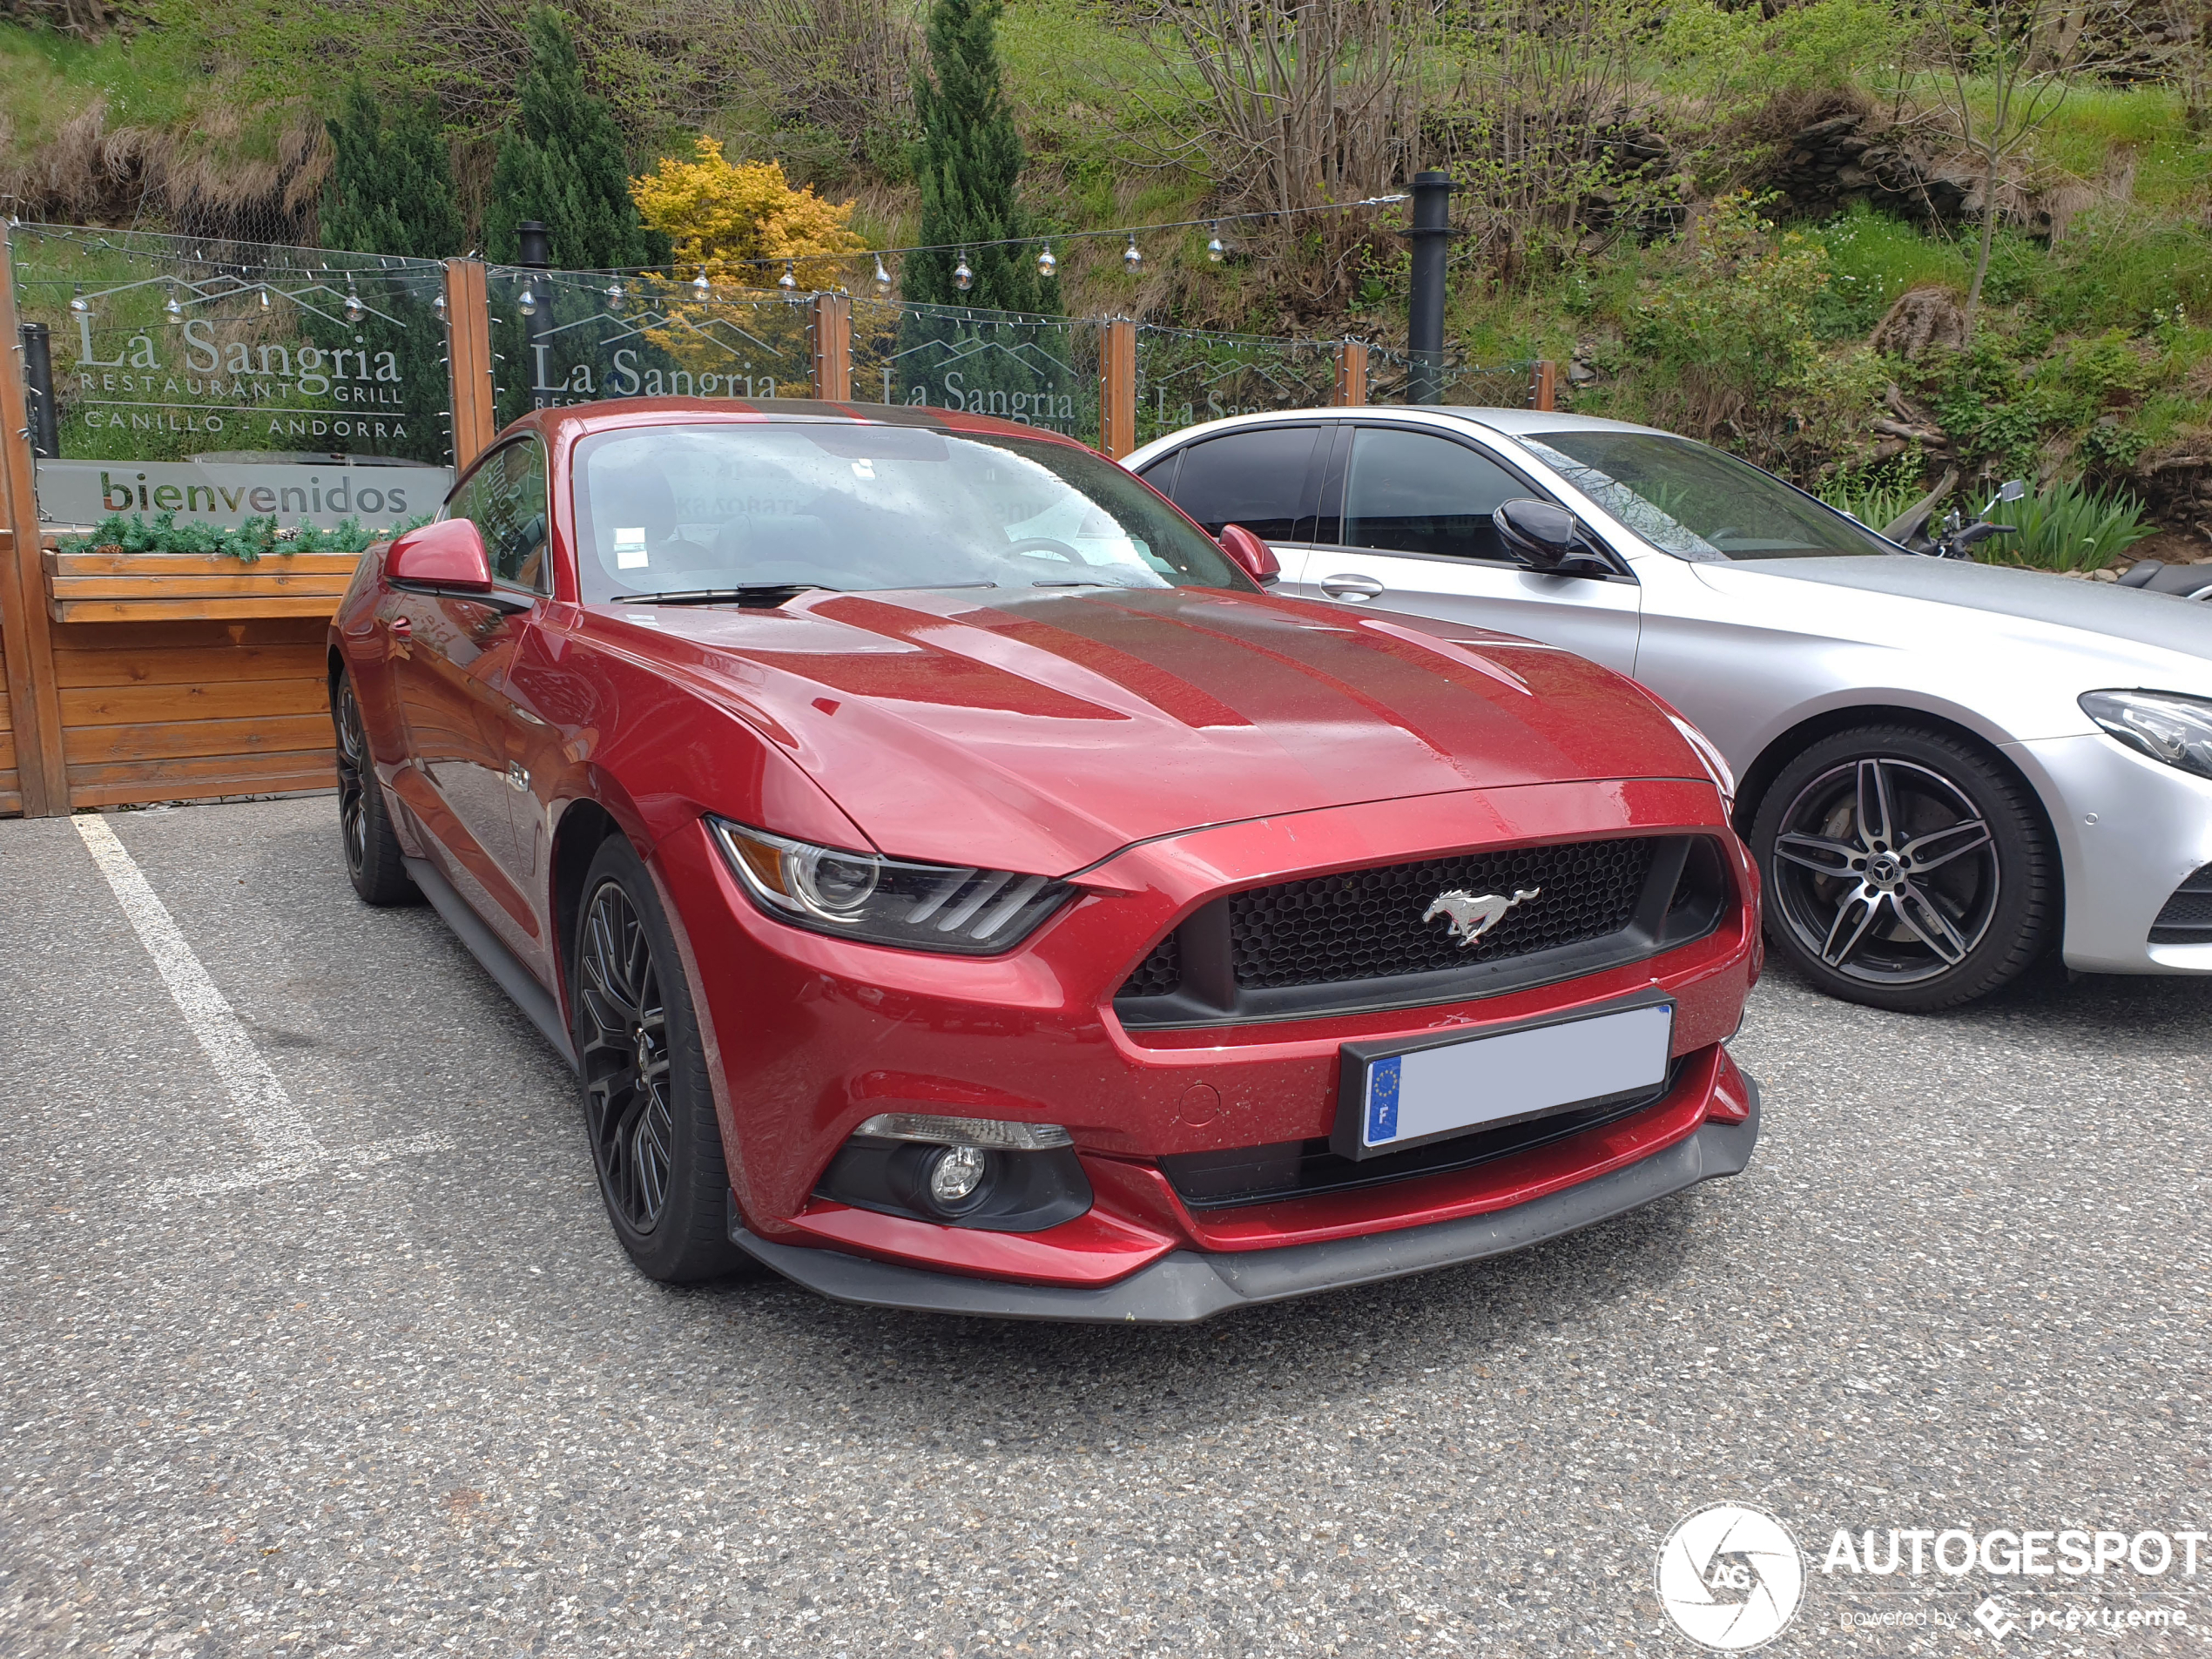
900, 0, 1057, 312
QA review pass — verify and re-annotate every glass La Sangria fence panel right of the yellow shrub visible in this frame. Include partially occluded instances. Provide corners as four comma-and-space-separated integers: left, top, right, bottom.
852, 299, 1102, 445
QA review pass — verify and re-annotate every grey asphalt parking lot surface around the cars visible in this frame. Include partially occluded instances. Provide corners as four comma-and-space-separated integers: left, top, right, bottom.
0, 799, 2212, 1659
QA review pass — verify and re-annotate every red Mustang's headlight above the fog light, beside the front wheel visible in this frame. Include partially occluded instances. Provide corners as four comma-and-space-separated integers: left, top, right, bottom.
708, 819, 1075, 955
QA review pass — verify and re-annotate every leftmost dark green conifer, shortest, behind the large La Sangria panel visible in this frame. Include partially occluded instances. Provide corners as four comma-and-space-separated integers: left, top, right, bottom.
323, 75, 467, 259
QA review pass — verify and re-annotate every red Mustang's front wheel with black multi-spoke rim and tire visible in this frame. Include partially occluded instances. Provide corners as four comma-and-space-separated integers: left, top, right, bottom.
569, 834, 750, 1285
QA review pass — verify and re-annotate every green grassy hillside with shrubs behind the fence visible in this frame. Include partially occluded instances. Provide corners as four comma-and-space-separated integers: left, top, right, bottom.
0, 0, 2212, 557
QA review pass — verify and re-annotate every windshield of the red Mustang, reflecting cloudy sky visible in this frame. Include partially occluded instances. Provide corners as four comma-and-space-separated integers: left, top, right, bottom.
573, 421, 1252, 604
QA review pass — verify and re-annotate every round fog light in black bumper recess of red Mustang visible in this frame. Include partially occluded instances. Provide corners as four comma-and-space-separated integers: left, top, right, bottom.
814, 1113, 1090, 1232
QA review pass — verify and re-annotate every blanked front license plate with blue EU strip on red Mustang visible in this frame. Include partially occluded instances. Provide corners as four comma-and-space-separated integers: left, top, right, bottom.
1330, 1002, 1675, 1159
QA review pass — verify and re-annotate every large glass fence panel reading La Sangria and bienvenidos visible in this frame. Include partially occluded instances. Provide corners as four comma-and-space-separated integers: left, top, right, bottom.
7, 224, 454, 527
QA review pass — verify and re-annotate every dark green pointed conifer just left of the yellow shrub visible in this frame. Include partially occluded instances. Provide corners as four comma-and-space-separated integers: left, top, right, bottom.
484, 7, 668, 270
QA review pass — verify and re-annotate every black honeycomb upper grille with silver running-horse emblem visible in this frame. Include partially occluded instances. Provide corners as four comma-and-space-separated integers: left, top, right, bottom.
1115, 836, 1730, 1027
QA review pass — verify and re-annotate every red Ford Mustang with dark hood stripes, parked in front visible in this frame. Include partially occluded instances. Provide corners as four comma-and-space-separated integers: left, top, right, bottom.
329, 401, 1758, 1320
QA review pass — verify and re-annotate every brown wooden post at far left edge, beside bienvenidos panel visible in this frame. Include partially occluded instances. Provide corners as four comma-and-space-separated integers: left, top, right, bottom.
0, 234, 69, 819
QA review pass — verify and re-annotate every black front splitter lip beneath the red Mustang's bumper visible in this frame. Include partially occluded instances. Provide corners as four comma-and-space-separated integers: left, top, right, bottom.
730, 1075, 1758, 1325
